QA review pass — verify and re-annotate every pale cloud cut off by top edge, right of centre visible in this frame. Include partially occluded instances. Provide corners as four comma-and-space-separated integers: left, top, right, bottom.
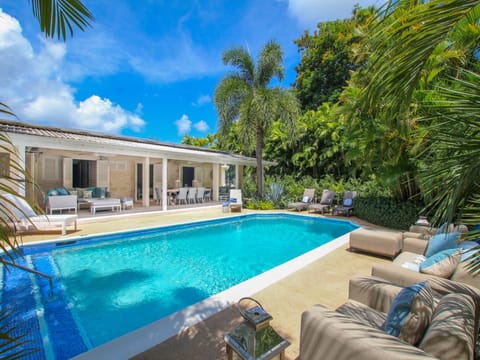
287, 0, 378, 29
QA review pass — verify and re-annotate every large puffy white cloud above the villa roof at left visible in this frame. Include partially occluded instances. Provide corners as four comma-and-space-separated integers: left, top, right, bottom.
0, 9, 145, 133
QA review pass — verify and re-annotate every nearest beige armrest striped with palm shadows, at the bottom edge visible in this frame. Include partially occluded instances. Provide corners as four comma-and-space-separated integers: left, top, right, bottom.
300, 305, 433, 360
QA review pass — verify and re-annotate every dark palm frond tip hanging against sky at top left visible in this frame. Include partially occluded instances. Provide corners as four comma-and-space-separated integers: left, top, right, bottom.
30, 0, 94, 41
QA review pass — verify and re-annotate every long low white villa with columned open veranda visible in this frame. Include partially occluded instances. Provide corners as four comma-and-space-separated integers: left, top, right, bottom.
0, 120, 262, 210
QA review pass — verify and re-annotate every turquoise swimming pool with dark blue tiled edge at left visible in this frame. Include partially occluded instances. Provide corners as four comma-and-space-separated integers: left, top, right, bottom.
2, 214, 356, 359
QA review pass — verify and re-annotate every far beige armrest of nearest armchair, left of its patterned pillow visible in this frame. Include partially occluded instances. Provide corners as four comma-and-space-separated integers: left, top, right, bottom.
348, 276, 403, 313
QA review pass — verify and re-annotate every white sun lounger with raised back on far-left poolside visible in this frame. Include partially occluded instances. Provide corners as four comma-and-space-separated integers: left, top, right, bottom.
2, 194, 78, 235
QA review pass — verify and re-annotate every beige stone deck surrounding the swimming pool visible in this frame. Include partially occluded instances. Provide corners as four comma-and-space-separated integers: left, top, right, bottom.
18, 205, 390, 360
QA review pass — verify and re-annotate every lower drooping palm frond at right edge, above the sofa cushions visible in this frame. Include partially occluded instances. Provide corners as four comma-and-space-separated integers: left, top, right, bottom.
419, 71, 480, 225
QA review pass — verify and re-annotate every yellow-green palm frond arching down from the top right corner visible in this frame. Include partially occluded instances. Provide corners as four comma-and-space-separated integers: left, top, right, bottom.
363, 0, 480, 116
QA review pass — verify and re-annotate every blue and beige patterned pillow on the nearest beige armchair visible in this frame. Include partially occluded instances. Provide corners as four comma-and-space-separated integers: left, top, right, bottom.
383, 281, 434, 345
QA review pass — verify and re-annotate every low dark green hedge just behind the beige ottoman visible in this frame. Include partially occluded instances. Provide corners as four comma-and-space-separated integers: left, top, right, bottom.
354, 196, 422, 230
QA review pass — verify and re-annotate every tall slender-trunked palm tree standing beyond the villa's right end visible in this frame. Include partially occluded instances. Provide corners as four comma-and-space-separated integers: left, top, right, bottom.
214, 40, 299, 197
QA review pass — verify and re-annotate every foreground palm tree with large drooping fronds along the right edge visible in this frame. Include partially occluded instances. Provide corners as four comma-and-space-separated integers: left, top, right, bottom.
364, 0, 480, 271
